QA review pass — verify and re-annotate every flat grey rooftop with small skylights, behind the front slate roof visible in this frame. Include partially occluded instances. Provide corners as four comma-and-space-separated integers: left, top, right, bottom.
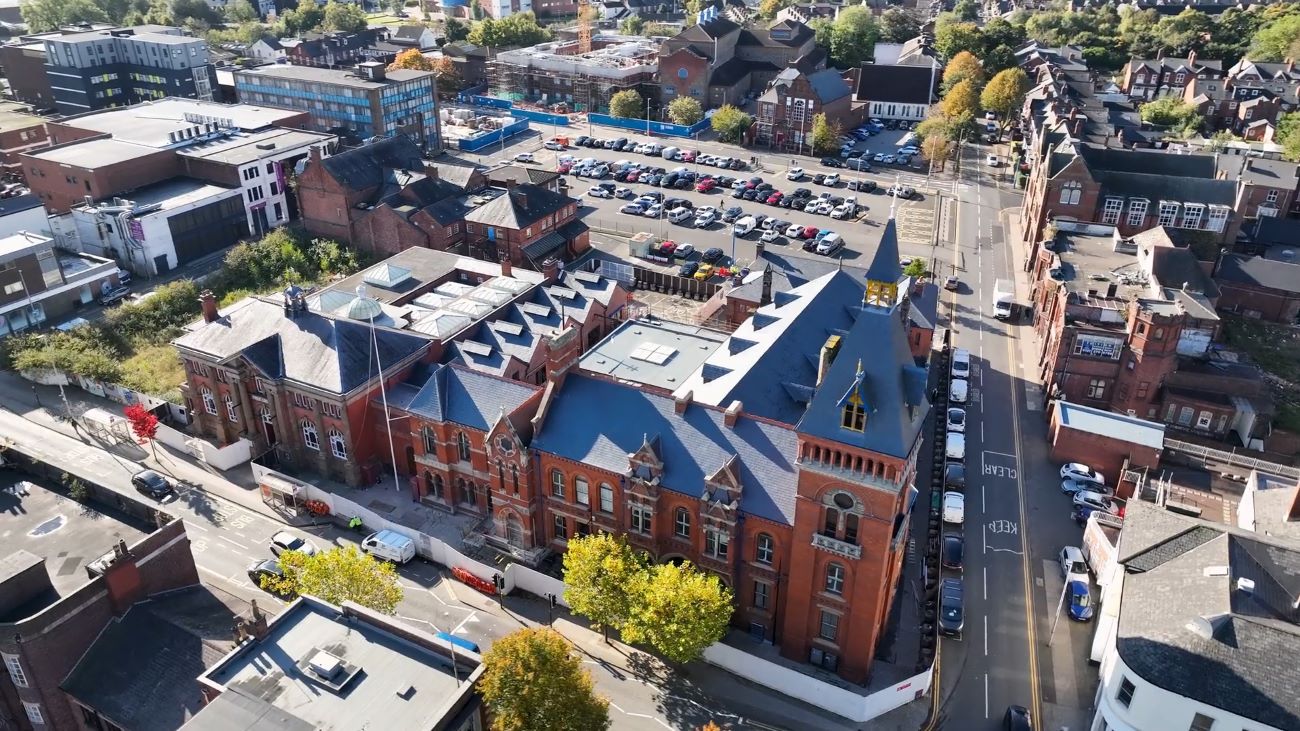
579, 319, 727, 392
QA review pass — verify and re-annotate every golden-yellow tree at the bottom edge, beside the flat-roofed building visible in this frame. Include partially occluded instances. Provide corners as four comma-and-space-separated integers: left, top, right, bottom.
478, 627, 610, 731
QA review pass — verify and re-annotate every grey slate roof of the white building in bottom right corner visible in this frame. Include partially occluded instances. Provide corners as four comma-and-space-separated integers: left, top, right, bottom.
1115, 501, 1300, 731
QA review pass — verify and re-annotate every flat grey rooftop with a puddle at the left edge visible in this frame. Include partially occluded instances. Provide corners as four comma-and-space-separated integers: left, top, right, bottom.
0, 471, 148, 614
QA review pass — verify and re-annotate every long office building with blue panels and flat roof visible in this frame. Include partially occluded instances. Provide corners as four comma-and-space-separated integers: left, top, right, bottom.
234, 61, 442, 153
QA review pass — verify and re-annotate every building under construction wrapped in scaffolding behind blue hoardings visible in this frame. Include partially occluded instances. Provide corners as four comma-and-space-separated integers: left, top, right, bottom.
488, 35, 659, 113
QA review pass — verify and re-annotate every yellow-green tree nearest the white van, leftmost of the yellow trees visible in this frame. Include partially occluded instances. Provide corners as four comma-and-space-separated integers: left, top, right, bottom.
261, 546, 402, 614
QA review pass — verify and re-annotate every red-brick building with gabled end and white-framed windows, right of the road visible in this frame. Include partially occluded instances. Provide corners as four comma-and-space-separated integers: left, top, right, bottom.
1022, 134, 1242, 264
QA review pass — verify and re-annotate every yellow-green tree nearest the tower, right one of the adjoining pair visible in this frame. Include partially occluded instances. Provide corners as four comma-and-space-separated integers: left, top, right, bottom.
623, 562, 735, 662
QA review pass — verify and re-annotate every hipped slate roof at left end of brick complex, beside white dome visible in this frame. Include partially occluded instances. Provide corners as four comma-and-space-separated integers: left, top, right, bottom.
172, 298, 430, 394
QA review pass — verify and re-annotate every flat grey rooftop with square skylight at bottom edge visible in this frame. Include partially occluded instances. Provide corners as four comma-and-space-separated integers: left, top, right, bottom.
205, 600, 472, 731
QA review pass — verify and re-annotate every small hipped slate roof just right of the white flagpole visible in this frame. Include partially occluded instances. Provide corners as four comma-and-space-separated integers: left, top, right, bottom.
390, 366, 540, 432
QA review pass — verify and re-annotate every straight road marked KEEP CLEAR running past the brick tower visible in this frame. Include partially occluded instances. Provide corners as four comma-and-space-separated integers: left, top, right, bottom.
939, 147, 1096, 730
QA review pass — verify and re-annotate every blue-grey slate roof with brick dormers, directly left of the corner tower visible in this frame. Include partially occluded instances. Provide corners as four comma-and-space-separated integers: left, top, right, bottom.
533, 373, 797, 525
